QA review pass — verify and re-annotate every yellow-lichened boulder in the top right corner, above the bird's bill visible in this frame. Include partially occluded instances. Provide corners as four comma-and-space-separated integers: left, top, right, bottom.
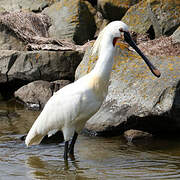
122, 0, 180, 37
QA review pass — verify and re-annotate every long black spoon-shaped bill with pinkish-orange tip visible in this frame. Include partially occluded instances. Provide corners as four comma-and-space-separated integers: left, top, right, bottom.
124, 31, 161, 77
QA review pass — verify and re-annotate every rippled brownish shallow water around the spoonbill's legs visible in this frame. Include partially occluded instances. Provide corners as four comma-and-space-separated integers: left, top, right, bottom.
0, 102, 180, 180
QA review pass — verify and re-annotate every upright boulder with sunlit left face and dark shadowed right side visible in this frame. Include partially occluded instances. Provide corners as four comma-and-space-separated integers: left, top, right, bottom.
43, 0, 96, 44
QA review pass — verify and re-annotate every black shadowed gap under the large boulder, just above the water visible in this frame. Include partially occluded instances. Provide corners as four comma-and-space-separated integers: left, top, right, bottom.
83, 115, 179, 137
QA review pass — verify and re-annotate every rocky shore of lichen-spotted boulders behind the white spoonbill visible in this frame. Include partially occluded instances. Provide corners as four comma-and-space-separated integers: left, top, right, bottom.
0, 0, 180, 136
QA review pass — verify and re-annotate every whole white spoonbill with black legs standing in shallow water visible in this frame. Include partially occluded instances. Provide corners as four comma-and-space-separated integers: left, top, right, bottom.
25, 21, 160, 160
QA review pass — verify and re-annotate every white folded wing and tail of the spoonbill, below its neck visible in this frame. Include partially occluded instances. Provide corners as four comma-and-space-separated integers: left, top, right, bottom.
25, 75, 100, 145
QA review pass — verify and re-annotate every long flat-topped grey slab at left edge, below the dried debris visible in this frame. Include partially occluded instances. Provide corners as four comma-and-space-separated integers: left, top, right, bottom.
0, 50, 83, 96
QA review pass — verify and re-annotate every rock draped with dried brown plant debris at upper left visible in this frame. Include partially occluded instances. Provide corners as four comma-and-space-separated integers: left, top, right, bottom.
0, 12, 80, 51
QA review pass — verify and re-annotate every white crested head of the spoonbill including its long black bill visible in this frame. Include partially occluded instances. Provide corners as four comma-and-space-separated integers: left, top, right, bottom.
92, 21, 161, 77
